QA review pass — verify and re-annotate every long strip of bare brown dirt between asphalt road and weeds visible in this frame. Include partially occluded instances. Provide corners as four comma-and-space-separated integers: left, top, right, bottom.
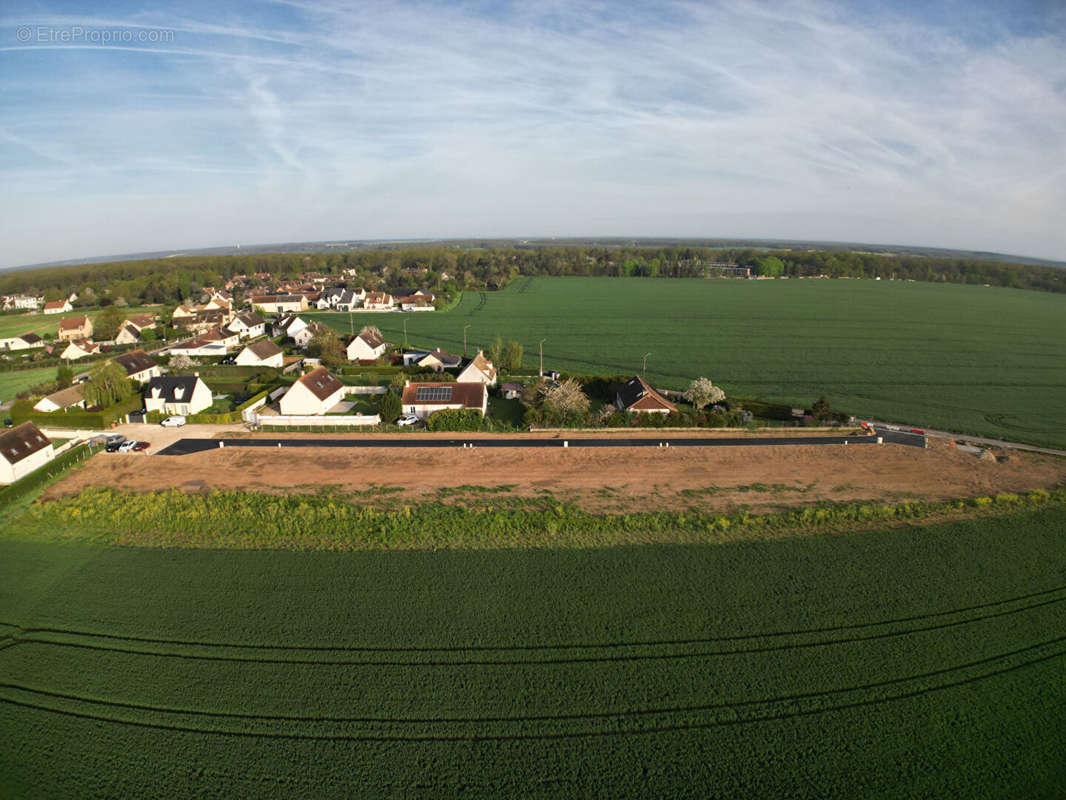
46, 444, 1066, 511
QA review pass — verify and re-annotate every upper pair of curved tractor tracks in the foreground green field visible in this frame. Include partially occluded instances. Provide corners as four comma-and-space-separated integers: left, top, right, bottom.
7, 588, 1066, 668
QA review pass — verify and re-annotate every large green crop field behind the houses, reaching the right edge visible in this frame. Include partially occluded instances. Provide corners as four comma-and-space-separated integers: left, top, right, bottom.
316, 277, 1066, 447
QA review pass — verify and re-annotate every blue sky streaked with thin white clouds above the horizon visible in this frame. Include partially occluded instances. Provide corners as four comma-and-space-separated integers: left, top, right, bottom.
0, 0, 1066, 267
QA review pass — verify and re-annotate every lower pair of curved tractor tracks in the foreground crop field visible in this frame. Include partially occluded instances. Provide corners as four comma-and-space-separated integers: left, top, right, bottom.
0, 636, 1066, 741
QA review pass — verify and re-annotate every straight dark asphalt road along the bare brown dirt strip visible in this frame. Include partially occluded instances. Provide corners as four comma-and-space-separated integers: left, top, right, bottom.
157, 431, 925, 455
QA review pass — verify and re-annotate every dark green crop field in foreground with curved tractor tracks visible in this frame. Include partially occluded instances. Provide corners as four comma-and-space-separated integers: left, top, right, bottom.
0, 509, 1066, 799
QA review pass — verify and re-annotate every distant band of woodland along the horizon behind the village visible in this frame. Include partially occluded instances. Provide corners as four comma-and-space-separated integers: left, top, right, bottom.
0, 245, 1066, 305
